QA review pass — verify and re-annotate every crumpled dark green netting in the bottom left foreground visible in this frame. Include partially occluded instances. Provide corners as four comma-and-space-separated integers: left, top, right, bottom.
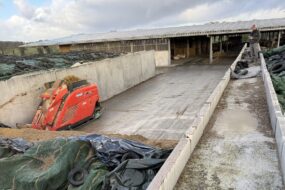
0, 139, 108, 190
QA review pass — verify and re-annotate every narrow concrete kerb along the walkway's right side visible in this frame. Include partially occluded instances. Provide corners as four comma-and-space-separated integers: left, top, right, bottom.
260, 53, 285, 182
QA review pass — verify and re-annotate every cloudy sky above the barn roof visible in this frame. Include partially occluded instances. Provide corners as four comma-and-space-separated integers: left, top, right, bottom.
0, 0, 285, 42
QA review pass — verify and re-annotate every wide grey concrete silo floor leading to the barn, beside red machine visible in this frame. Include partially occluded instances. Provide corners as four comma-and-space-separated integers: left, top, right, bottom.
78, 59, 233, 140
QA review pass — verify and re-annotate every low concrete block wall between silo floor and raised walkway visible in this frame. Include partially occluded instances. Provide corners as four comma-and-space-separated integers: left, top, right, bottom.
148, 44, 246, 190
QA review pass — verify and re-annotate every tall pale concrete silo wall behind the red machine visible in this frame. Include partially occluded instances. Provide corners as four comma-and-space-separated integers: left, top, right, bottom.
0, 51, 155, 126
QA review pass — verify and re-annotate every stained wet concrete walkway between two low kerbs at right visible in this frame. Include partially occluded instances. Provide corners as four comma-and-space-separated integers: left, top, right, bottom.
175, 77, 284, 190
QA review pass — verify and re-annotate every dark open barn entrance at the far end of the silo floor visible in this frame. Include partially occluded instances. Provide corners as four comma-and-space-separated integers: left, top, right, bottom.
170, 34, 246, 64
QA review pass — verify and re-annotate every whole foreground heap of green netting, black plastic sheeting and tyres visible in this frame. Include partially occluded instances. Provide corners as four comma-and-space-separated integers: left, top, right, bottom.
0, 134, 171, 190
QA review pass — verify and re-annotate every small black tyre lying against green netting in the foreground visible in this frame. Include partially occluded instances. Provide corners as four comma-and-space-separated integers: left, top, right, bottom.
67, 168, 88, 186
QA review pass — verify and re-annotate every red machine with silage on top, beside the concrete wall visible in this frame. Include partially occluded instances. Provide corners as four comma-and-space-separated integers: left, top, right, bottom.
32, 80, 100, 131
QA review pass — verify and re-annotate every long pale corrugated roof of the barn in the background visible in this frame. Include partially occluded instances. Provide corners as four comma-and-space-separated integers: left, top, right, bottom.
23, 18, 285, 47
